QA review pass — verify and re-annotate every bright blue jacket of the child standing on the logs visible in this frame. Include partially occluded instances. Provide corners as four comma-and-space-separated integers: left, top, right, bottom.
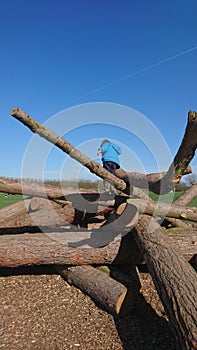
99, 142, 122, 165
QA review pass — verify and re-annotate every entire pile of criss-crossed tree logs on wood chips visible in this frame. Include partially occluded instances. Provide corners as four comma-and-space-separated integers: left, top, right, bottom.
0, 109, 197, 350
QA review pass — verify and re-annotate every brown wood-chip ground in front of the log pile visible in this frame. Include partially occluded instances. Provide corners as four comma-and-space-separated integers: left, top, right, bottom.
0, 267, 175, 350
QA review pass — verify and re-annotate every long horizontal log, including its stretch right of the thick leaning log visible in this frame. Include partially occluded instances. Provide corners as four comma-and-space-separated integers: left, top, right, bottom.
0, 228, 197, 267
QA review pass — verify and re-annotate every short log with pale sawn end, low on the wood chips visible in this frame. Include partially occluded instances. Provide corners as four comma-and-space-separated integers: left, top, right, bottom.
57, 265, 139, 316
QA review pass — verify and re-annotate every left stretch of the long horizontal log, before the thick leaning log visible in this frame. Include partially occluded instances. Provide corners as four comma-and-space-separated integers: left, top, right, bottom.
0, 231, 143, 267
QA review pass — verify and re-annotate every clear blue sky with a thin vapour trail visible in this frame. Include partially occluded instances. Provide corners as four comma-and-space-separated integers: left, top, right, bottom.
0, 0, 197, 182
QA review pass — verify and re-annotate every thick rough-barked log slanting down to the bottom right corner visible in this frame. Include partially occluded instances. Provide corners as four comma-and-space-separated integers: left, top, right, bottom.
132, 215, 197, 350
